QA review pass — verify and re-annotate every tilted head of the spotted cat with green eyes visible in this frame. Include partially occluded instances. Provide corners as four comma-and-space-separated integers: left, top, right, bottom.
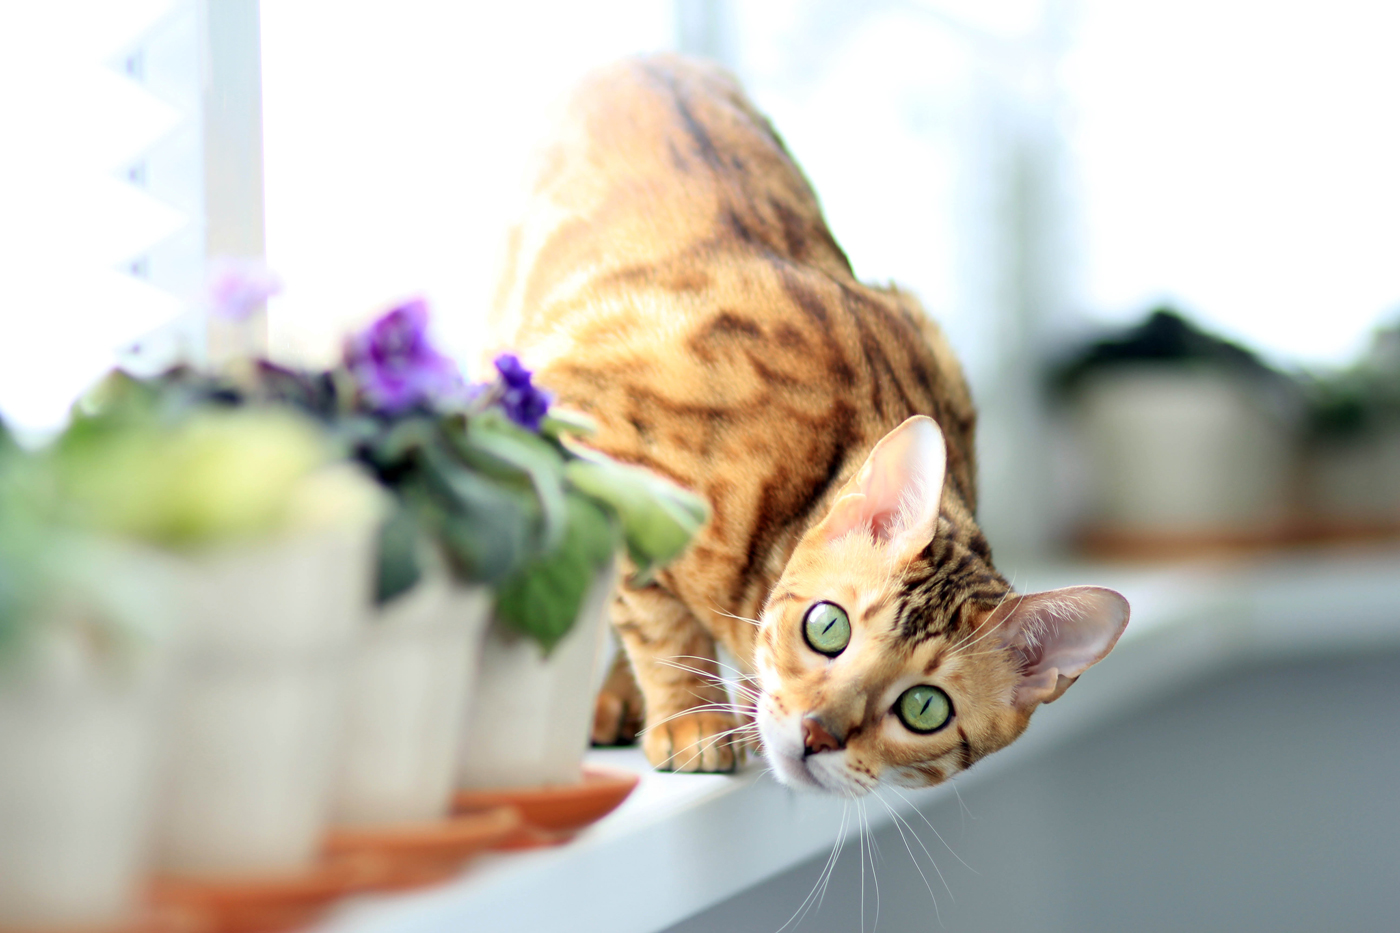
755, 416, 1128, 794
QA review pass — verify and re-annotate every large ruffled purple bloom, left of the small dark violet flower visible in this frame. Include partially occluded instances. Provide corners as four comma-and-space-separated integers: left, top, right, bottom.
344, 298, 462, 415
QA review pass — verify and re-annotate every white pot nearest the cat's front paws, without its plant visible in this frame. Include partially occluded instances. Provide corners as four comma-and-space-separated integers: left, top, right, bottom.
458, 566, 617, 787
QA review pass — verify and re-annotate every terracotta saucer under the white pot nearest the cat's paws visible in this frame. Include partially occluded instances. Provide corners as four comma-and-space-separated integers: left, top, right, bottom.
454, 768, 640, 849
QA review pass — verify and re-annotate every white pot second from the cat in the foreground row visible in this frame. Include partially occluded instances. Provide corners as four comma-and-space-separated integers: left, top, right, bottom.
333, 574, 491, 825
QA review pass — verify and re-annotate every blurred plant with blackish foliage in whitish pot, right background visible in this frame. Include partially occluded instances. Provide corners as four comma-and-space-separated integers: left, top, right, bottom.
1057, 308, 1295, 551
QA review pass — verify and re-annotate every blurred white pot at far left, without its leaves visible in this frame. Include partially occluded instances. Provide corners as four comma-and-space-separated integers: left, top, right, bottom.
0, 548, 173, 929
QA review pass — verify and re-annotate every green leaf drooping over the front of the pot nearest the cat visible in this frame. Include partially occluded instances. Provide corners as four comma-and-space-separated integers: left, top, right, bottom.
496, 493, 617, 653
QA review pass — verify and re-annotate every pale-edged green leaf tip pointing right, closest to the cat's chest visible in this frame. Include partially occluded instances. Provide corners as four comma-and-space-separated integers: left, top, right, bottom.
564, 454, 710, 581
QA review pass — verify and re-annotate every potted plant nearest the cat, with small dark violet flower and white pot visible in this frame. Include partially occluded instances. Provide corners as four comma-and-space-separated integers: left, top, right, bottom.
461, 356, 708, 789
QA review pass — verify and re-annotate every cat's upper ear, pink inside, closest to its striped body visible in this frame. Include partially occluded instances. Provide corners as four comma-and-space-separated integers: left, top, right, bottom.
818, 415, 948, 559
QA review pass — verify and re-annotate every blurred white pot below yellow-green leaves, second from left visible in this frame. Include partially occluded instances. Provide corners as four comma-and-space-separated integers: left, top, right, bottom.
155, 525, 374, 876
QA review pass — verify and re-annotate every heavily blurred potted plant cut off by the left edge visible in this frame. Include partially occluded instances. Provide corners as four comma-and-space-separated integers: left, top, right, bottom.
0, 424, 169, 929
